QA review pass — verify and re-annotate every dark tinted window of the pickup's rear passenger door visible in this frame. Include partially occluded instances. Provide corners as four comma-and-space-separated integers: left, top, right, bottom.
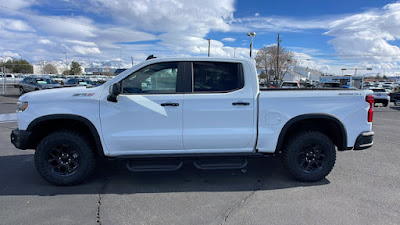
193, 62, 244, 92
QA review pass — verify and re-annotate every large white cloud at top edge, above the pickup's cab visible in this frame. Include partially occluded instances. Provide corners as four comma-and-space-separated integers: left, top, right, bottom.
86, 0, 235, 37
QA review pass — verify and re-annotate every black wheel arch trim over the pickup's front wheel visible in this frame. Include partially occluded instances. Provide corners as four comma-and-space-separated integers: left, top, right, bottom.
26, 114, 104, 156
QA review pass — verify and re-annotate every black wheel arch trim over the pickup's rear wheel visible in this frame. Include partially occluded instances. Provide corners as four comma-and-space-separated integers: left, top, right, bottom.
276, 114, 347, 152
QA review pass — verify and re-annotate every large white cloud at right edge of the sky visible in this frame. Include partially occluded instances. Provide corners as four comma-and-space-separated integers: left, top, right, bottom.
325, 3, 400, 68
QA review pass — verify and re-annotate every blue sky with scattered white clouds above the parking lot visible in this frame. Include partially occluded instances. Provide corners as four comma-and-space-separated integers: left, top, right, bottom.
0, 0, 400, 75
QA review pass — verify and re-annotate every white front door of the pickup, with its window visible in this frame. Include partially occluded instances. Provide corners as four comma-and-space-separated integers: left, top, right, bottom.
100, 62, 183, 156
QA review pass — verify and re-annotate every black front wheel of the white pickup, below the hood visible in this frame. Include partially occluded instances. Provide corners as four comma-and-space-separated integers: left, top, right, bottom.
35, 130, 96, 185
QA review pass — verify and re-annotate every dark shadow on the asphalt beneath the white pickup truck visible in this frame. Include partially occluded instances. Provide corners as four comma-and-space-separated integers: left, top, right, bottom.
0, 154, 330, 196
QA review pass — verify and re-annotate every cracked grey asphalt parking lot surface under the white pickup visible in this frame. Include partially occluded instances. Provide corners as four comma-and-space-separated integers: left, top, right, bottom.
0, 88, 400, 225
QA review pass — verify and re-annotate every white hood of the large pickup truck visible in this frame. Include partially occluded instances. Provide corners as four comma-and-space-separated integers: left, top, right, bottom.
18, 86, 103, 102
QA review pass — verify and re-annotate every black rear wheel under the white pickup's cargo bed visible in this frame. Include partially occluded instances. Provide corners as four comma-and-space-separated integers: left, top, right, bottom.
282, 131, 336, 182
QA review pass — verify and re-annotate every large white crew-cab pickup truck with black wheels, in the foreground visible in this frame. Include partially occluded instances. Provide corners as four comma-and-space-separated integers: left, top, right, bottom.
11, 58, 374, 185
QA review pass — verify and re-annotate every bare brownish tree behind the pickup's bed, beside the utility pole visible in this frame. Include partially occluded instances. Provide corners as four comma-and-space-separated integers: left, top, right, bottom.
255, 45, 296, 86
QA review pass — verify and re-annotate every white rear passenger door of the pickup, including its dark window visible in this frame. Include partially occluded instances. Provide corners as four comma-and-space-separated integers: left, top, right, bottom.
183, 61, 256, 152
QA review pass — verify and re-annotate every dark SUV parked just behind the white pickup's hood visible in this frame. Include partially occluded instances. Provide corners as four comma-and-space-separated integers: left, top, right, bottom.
19, 77, 62, 95
